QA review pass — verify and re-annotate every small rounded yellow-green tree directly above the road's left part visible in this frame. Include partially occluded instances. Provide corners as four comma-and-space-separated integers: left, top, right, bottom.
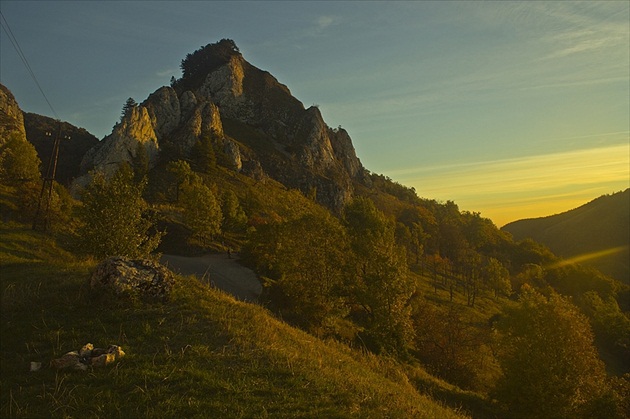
181, 176, 223, 246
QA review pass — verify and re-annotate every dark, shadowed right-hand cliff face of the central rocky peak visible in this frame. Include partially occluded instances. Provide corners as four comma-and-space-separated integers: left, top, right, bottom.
195, 50, 364, 210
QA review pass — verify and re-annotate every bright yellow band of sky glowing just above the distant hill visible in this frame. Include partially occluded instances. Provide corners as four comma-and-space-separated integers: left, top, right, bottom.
392, 140, 630, 226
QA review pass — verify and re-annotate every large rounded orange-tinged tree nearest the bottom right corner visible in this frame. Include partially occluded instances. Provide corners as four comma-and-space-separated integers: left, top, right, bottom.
494, 285, 605, 418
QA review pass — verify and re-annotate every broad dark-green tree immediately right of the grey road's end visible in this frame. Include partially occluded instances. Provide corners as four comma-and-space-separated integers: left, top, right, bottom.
248, 211, 350, 335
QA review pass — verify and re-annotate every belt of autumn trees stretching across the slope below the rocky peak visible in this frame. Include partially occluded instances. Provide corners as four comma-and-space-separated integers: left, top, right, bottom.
0, 119, 630, 417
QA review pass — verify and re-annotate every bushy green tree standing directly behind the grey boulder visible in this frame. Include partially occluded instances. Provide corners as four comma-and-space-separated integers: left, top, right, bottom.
79, 164, 163, 257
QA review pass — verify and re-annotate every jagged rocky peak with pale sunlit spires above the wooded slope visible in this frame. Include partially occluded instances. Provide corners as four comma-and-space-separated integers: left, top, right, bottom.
79, 40, 365, 210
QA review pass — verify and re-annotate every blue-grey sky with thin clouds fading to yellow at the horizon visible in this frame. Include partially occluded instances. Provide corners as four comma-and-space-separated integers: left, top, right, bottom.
0, 0, 630, 227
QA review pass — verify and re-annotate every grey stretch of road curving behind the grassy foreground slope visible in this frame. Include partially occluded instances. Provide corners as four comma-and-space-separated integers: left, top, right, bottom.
160, 254, 262, 302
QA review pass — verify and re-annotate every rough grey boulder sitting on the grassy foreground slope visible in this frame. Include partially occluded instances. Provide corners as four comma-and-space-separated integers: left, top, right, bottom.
90, 256, 175, 301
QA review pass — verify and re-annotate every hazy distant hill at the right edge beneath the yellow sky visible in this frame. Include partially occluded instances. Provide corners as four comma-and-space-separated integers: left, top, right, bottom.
502, 189, 630, 283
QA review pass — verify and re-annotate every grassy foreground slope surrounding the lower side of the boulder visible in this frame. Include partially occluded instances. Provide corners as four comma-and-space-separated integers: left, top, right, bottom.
0, 224, 465, 418
